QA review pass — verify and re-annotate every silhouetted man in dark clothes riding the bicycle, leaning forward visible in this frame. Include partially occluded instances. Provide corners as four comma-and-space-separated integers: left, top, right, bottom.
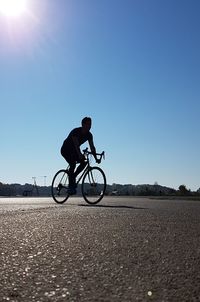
61, 117, 99, 195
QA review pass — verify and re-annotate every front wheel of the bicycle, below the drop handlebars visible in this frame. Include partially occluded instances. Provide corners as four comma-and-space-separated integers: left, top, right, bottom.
81, 167, 106, 204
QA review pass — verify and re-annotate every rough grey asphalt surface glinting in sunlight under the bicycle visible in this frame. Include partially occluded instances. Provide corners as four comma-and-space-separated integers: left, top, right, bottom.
0, 197, 200, 302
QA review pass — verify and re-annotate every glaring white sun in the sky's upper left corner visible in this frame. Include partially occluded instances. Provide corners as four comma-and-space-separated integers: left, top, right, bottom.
0, 0, 27, 17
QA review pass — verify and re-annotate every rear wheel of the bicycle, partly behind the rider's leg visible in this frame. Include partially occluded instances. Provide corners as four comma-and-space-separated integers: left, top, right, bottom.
51, 170, 69, 203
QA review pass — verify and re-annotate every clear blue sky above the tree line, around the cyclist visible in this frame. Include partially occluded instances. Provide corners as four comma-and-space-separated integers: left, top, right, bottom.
0, 0, 200, 190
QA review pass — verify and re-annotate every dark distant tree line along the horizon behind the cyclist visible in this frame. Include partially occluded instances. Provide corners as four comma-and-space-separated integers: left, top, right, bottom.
0, 182, 200, 197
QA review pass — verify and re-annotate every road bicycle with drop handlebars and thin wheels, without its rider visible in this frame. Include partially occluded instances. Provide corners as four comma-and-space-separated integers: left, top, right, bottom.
51, 148, 106, 204
